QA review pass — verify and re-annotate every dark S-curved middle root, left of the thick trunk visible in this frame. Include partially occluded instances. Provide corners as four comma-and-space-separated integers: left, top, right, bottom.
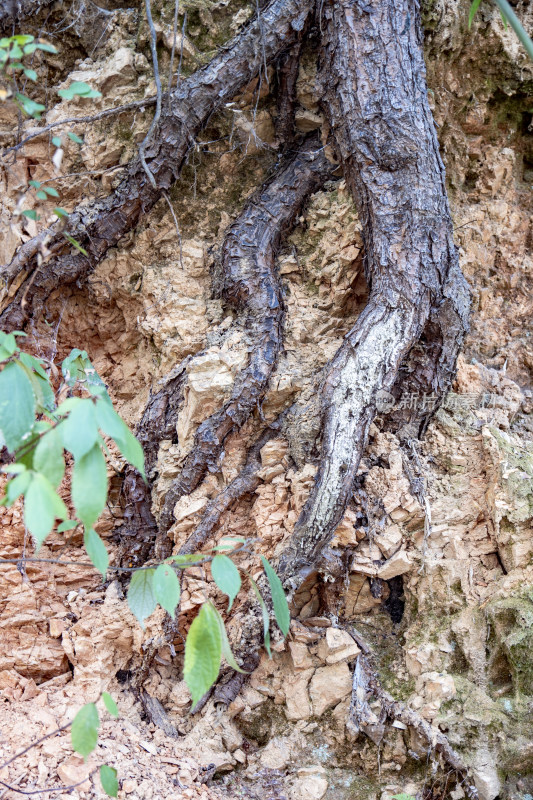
159, 139, 332, 545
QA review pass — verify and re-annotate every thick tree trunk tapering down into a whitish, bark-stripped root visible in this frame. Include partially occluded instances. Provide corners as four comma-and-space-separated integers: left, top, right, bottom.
279, 0, 469, 590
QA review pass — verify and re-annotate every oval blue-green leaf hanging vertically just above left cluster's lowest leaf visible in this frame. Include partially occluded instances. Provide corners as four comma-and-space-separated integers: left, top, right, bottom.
71, 444, 107, 528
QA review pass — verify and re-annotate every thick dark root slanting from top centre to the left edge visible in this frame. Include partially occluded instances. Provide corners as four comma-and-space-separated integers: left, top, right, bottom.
0, 0, 312, 330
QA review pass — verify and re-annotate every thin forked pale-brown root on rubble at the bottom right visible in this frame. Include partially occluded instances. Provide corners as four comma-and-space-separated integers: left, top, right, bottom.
347, 648, 477, 798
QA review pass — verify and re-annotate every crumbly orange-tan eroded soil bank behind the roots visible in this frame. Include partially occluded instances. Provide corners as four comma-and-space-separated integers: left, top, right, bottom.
0, 0, 533, 800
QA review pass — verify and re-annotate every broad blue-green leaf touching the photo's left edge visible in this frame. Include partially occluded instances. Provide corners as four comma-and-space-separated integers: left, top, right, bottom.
0, 361, 35, 453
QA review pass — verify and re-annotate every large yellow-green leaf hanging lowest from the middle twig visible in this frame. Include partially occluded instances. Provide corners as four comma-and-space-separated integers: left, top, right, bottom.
183, 603, 222, 708
